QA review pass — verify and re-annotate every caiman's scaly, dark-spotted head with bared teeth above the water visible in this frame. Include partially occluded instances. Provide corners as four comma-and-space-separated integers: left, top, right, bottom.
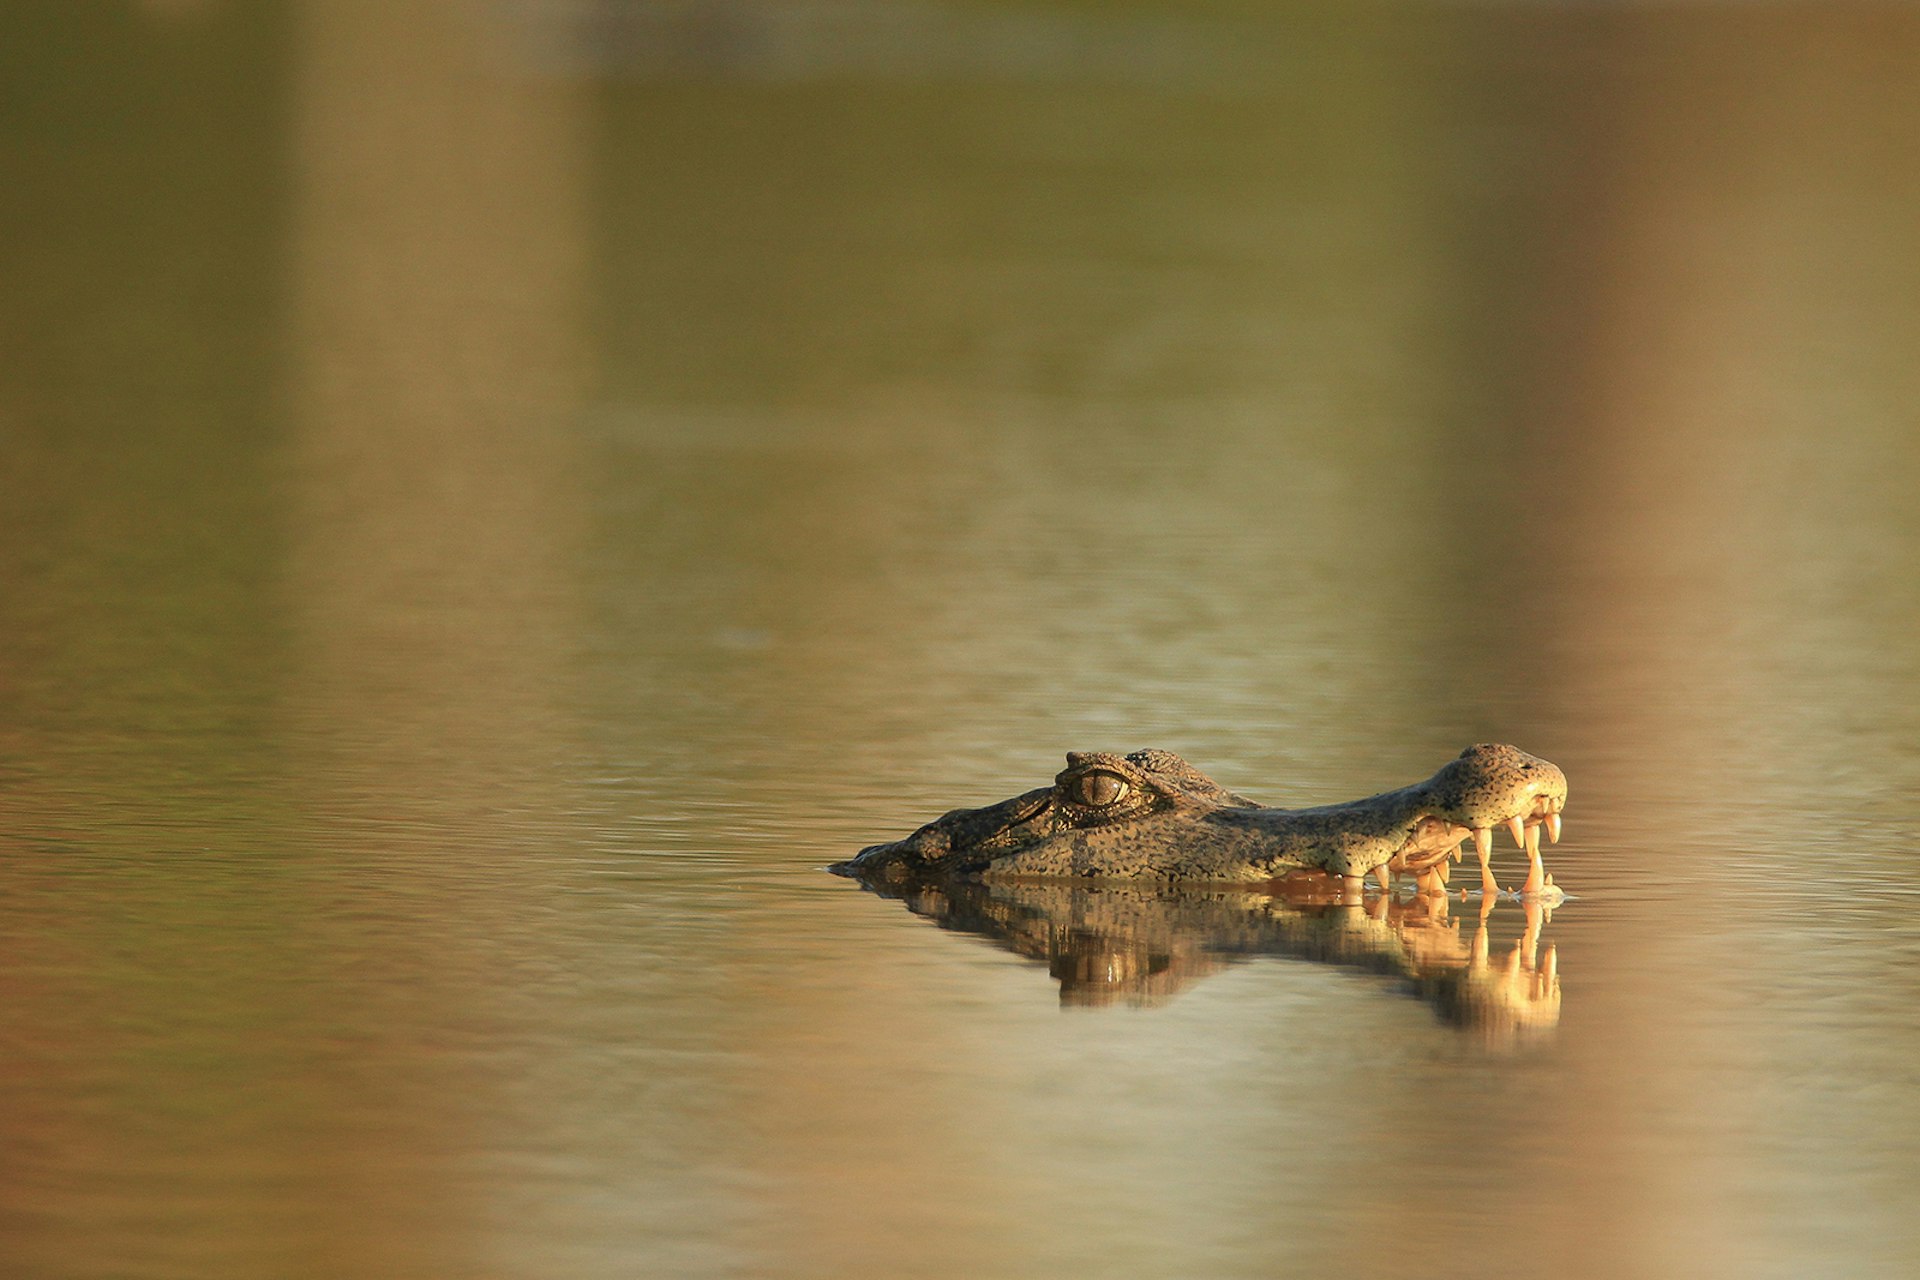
828, 743, 1567, 894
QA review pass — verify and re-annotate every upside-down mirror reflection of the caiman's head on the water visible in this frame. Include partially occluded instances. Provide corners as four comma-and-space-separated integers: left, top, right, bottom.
840, 877, 1561, 1038
